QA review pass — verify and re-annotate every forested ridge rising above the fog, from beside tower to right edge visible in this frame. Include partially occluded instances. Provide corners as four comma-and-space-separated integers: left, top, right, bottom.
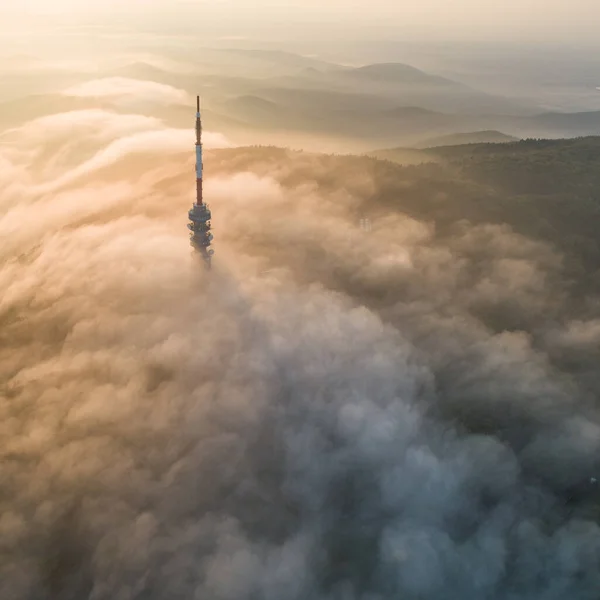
213, 137, 600, 289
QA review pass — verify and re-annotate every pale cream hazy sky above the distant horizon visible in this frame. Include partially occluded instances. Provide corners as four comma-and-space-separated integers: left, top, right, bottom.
0, 0, 600, 44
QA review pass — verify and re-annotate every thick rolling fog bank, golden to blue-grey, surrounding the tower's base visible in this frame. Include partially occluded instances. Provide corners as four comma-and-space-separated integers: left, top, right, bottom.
0, 105, 600, 600
